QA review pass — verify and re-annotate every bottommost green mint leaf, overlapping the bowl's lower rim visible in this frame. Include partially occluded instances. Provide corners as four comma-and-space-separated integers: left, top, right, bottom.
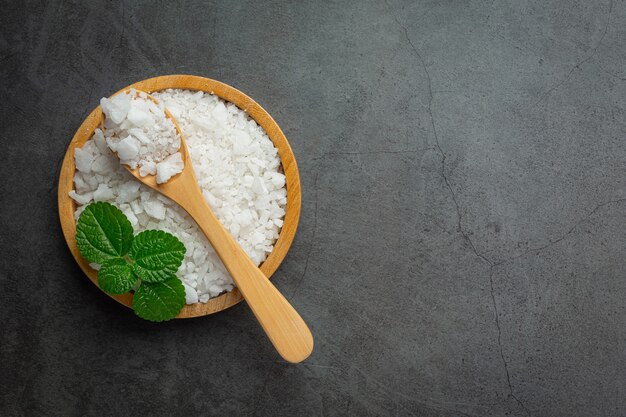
133, 275, 185, 321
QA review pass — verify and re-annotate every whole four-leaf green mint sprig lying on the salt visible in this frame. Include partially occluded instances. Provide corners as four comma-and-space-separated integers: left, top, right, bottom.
76, 202, 185, 321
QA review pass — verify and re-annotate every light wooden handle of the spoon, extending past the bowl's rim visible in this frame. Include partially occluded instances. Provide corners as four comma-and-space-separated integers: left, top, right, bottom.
179, 188, 313, 363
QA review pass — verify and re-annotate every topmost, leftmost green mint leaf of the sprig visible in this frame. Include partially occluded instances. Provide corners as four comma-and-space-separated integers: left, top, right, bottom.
76, 203, 133, 265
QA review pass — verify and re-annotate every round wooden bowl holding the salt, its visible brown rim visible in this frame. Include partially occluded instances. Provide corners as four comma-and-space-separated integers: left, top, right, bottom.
58, 75, 301, 318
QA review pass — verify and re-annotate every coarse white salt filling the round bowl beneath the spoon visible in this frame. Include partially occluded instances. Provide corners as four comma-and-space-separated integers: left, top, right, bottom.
70, 89, 287, 304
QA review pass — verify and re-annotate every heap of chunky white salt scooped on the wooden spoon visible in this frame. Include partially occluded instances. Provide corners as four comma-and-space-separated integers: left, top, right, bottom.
100, 89, 185, 184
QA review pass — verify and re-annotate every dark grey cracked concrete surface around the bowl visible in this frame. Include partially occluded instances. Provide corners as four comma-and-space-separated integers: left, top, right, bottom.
0, 0, 626, 417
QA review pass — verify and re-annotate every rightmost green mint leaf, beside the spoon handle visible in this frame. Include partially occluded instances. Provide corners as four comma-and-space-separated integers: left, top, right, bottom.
130, 230, 185, 282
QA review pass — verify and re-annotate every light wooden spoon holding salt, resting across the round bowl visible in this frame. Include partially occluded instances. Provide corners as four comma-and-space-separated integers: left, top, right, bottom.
105, 90, 313, 363
